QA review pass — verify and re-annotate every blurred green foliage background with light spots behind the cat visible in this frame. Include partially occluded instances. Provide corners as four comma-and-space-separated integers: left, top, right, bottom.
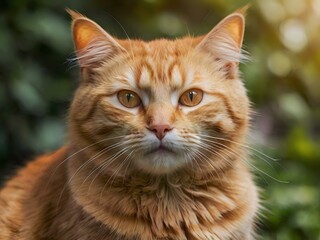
0, 0, 320, 240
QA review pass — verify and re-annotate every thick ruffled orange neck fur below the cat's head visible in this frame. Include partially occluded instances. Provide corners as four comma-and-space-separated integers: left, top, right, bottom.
68, 147, 254, 239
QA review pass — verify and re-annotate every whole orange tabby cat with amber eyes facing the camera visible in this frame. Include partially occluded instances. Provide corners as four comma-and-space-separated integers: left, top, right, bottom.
0, 7, 259, 240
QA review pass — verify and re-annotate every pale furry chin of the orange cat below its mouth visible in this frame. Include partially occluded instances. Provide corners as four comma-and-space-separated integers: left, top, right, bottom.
136, 151, 187, 174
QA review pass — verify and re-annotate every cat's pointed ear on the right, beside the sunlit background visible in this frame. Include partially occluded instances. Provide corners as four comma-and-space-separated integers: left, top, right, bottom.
197, 6, 248, 78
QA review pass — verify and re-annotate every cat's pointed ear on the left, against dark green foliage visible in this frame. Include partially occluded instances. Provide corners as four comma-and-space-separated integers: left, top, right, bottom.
67, 9, 125, 68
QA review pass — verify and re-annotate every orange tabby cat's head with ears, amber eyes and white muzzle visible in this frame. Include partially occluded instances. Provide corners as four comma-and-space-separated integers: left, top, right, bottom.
69, 7, 249, 174
